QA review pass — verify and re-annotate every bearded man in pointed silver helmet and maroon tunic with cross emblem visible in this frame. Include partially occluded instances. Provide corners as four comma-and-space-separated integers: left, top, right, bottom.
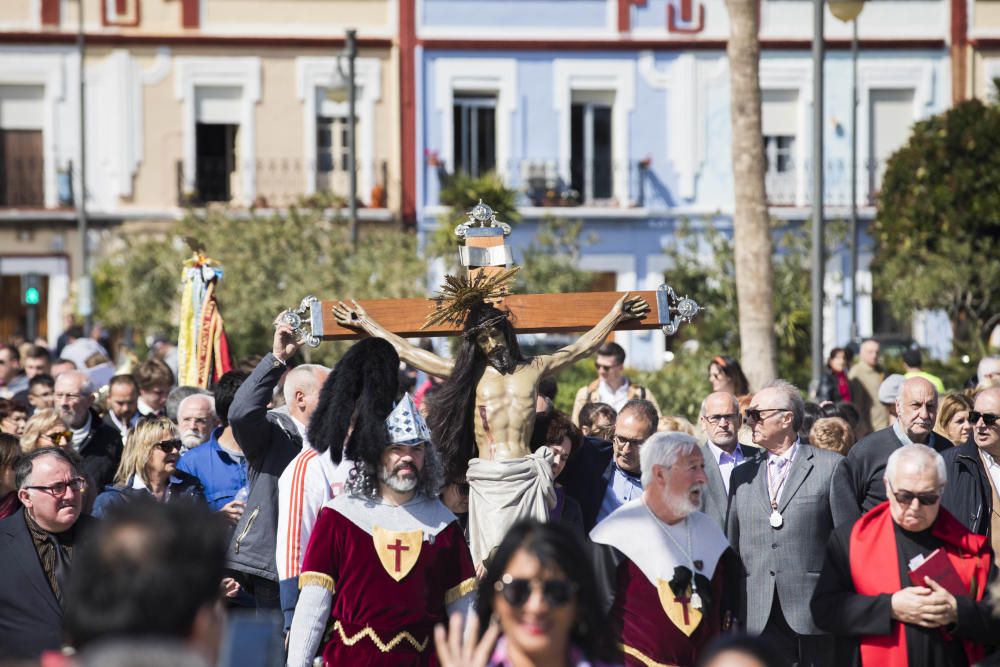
288, 394, 475, 667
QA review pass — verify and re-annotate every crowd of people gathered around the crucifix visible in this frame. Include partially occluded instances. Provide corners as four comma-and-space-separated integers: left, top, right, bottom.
0, 322, 1000, 667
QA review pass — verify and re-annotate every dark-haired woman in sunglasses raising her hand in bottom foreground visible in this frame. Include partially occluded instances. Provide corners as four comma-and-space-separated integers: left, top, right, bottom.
434, 520, 616, 667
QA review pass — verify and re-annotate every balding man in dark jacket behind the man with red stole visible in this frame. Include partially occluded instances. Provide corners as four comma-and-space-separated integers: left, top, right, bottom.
847, 377, 952, 513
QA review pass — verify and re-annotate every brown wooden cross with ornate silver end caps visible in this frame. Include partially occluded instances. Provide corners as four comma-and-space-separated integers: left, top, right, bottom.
283, 202, 701, 347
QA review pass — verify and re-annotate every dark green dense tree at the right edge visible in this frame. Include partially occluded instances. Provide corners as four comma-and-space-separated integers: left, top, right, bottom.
871, 100, 1000, 356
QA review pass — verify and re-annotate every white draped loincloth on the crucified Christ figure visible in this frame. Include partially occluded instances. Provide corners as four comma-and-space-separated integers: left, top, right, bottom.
466, 447, 556, 566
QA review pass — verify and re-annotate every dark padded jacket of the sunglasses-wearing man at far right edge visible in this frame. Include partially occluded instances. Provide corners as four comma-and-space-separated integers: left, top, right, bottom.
941, 443, 993, 536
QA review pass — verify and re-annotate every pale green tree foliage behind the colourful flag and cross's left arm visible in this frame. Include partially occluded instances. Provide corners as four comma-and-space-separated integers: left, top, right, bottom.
92, 207, 426, 363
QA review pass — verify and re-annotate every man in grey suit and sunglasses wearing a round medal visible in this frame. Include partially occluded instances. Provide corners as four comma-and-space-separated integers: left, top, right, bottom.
726, 380, 858, 666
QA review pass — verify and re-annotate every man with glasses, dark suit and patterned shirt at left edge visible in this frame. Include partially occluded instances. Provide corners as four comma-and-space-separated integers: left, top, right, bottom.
0, 447, 92, 662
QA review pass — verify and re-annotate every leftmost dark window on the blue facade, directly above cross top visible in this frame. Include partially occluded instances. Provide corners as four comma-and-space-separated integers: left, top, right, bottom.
452, 94, 497, 177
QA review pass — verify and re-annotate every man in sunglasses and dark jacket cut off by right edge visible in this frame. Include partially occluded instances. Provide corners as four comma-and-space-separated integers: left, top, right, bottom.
941, 387, 1000, 554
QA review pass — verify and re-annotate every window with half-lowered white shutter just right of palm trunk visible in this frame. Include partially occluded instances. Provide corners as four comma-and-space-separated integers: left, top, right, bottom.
761, 90, 798, 205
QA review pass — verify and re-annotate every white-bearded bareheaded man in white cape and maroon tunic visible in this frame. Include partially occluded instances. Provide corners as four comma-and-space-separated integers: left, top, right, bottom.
590, 433, 742, 666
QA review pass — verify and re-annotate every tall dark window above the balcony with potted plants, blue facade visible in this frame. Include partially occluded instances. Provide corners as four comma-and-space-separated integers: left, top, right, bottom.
569, 92, 614, 203
